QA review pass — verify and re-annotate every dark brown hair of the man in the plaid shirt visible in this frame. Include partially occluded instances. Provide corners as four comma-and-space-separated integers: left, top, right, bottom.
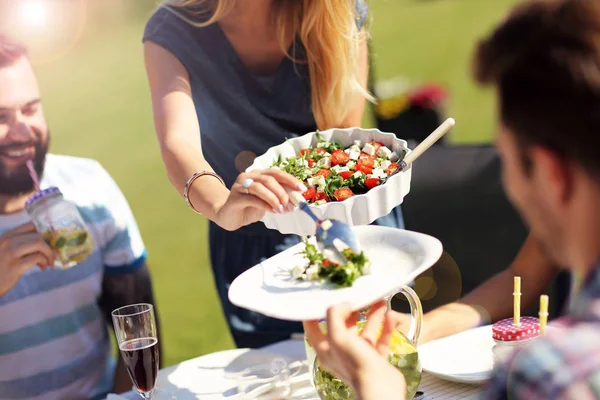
474, 0, 600, 177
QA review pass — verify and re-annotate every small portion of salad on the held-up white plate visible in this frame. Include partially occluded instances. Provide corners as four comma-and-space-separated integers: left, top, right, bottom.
291, 239, 371, 288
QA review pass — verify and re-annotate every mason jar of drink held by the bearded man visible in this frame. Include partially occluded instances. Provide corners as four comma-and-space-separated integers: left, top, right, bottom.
25, 187, 94, 269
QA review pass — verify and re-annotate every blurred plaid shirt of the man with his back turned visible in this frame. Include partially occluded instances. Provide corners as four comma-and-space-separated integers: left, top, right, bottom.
483, 263, 600, 400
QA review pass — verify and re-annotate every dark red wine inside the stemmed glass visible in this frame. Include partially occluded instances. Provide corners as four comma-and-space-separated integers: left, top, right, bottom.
119, 338, 158, 393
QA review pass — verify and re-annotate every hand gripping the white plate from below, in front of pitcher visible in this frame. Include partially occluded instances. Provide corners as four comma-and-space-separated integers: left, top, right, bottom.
304, 302, 406, 400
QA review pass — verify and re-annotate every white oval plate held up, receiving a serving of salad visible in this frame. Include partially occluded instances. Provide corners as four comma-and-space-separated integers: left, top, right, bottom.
229, 225, 442, 321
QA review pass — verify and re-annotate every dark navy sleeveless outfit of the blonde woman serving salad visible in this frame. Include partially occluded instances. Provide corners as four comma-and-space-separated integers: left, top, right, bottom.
143, 0, 403, 348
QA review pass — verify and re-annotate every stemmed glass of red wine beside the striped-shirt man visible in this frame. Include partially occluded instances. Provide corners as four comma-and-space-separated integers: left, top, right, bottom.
112, 303, 158, 399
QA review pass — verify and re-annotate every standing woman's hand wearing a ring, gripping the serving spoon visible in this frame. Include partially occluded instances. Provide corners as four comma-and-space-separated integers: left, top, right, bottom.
215, 168, 307, 231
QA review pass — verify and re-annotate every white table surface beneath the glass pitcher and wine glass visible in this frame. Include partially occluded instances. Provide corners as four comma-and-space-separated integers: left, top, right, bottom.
112, 340, 479, 400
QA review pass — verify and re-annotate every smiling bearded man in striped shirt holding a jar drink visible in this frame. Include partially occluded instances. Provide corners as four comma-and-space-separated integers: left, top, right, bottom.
0, 34, 161, 400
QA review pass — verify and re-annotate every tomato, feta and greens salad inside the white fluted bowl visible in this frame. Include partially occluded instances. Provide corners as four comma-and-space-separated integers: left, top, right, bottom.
272, 131, 405, 205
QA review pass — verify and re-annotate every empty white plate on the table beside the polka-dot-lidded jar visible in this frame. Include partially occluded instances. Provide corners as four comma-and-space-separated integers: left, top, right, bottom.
419, 325, 494, 384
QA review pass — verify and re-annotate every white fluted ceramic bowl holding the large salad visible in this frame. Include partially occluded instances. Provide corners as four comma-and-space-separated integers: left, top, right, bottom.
246, 128, 412, 236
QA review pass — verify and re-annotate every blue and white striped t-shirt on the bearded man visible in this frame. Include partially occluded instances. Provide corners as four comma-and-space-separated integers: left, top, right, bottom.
0, 154, 146, 400
